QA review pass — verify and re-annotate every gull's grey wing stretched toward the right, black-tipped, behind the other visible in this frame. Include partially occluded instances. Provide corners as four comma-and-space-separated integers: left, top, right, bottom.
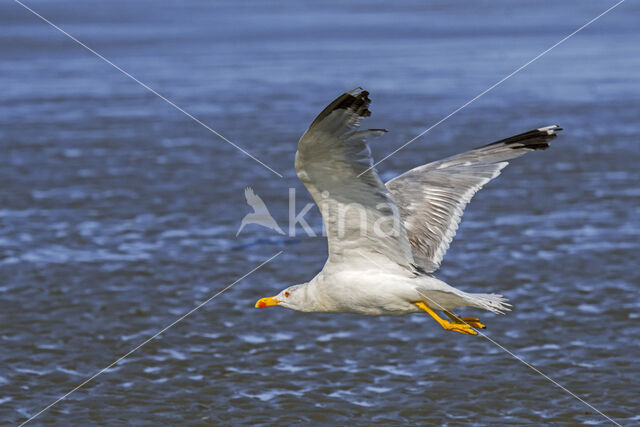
386, 125, 562, 272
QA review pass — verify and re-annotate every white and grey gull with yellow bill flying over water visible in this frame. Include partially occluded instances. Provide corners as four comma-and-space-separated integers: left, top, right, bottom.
255, 88, 562, 335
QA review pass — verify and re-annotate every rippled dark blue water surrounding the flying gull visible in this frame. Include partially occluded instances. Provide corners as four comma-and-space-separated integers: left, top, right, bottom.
0, 1, 640, 425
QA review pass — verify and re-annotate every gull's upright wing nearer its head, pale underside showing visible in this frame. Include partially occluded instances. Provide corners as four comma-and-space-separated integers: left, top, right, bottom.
296, 88, 413, 269
